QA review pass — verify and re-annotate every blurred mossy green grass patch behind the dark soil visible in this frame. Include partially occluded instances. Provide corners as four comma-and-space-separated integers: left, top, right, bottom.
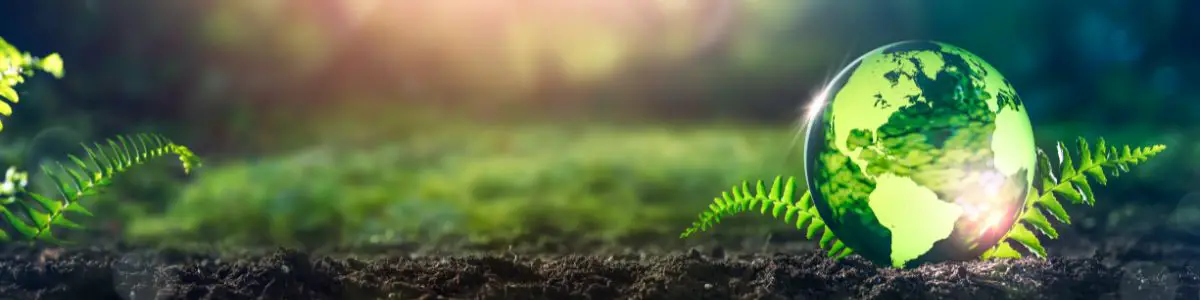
127, 125, 802, 246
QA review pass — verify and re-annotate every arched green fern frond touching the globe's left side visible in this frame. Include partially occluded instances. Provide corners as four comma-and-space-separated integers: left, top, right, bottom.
679, 176, 853, 259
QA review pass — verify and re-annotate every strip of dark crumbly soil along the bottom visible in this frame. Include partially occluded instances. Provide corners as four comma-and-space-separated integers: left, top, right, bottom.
0, 234, 1200, 300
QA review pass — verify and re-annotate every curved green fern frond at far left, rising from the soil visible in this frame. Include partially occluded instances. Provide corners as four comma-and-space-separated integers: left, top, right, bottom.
0, 134, 200, 244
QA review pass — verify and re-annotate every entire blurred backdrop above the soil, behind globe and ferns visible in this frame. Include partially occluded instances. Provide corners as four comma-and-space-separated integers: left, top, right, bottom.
0, 0, 1200, 247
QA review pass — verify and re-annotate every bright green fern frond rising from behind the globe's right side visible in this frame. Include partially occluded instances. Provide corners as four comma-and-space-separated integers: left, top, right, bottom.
983, 138, 1166, 259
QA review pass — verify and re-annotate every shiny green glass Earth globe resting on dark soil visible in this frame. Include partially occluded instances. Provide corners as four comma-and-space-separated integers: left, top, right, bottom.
804, 41, 1037, 268
